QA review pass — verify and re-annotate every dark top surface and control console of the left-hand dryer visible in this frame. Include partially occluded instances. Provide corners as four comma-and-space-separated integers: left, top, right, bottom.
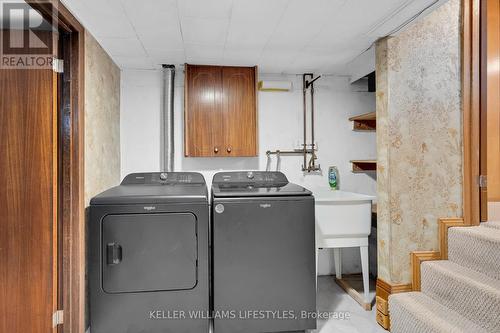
90, 172, 208, 205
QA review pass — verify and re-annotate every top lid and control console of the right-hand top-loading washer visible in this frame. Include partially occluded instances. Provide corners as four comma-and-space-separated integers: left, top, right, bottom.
212, 171, 312, 198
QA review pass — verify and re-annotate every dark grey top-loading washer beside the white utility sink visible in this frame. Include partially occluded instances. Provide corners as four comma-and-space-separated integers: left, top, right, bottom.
212, 171, 316, 333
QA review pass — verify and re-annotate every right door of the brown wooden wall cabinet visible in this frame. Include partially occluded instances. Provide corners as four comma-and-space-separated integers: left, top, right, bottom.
222, 67, 257, 156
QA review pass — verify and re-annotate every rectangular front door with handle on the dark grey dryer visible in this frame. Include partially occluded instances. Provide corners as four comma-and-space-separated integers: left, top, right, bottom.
101, 213, 198, 293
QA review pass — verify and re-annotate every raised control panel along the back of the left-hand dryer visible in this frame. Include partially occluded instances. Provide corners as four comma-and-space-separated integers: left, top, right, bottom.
121, 172, 205, 185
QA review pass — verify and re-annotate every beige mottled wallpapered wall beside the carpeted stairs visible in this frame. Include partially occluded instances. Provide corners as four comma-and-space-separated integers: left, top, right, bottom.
376, 0, 462, 284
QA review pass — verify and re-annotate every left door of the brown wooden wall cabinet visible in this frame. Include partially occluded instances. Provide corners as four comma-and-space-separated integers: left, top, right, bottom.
184, 65, 223, 157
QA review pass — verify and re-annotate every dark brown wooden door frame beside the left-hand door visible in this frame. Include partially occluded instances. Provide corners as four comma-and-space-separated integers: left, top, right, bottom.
27, 0, 86, 333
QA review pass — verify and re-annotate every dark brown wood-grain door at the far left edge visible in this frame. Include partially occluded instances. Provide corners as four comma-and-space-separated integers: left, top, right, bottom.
0, 54, 57, 333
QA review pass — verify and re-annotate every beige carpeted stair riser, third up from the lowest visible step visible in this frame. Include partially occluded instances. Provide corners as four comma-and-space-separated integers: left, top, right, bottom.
448, 227, 500, 280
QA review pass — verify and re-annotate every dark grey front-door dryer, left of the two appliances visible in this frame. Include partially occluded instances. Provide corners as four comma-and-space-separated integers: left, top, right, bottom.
89, 172, 209, 333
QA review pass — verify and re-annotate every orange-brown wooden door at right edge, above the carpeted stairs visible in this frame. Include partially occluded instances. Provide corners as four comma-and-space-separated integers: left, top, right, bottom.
481, 0, 500, 221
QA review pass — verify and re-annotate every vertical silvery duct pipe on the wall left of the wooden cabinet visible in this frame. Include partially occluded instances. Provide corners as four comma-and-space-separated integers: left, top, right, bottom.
160, 65, 175, 172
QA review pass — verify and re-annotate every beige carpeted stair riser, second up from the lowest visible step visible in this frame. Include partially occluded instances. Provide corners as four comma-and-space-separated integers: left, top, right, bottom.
421, 264, 500, 332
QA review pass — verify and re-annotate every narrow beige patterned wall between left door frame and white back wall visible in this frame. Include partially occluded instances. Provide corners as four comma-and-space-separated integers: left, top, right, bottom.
85, 32, 120, 206
